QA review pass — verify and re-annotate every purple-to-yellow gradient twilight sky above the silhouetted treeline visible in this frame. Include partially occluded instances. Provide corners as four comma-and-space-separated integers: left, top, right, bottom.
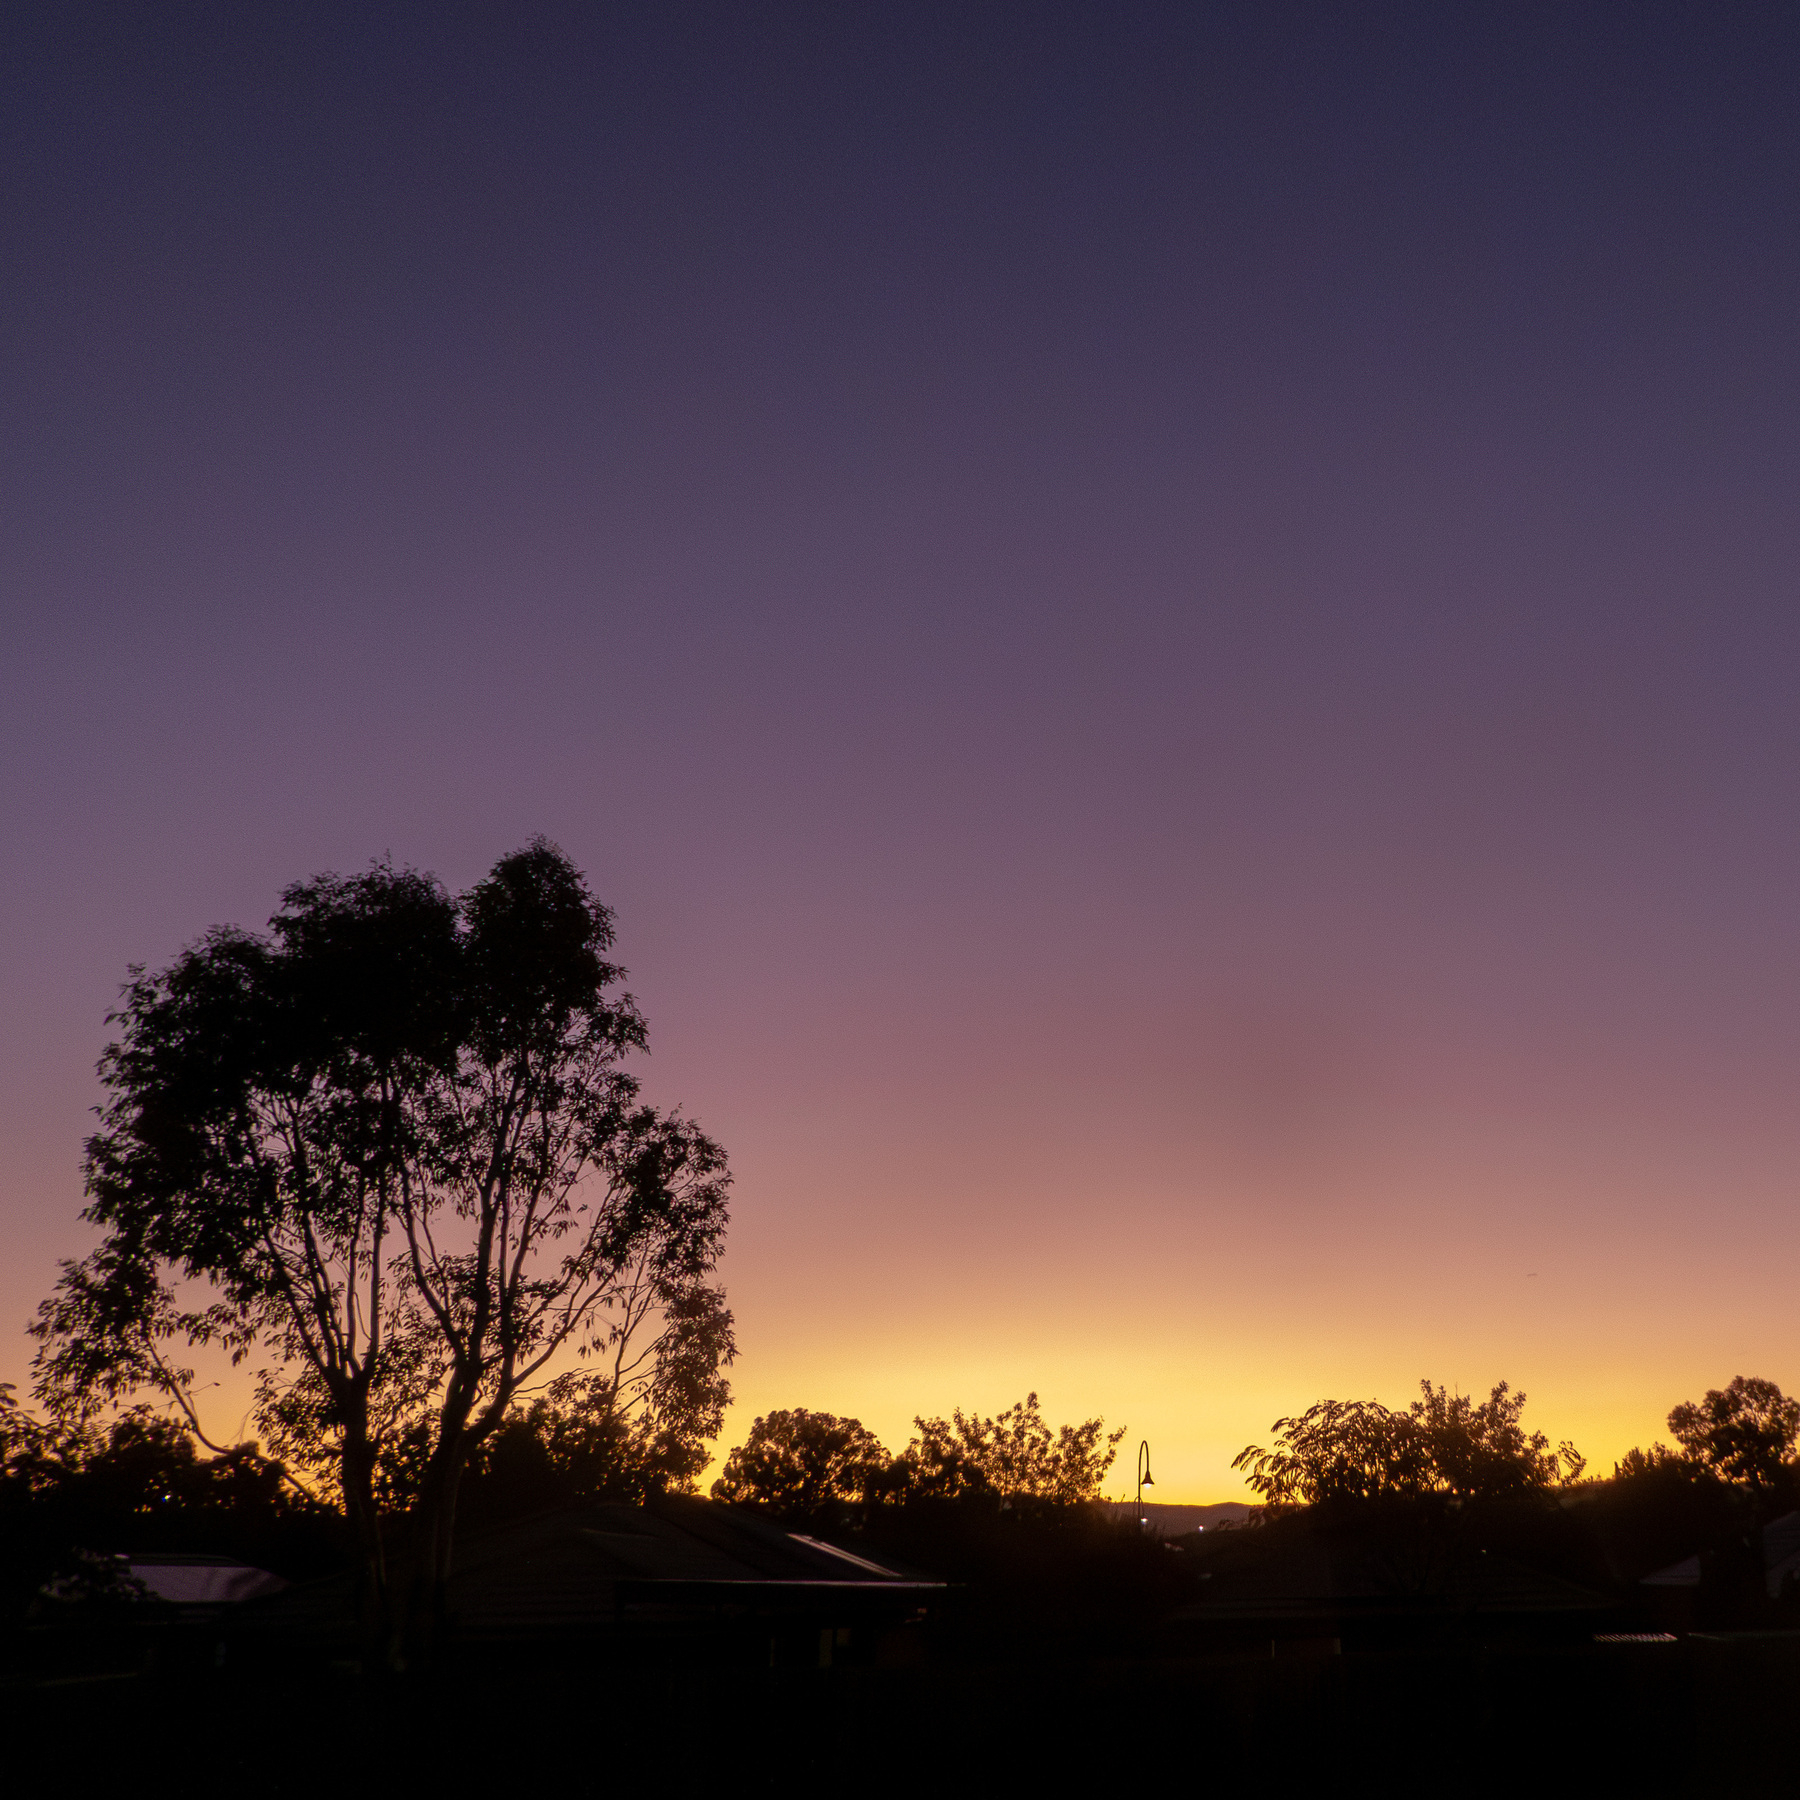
0, 10, 1800, 1501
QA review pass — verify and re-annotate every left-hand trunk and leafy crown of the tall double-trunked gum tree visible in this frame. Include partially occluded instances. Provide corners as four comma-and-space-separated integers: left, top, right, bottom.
36, 868, 459, 1589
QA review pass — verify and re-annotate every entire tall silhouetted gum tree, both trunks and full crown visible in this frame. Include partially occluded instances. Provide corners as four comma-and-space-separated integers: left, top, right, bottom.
34, 841, 734, 1645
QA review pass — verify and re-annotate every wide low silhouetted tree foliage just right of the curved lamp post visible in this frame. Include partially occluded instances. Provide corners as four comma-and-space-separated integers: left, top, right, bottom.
1231, 1381, 1586, 1510
